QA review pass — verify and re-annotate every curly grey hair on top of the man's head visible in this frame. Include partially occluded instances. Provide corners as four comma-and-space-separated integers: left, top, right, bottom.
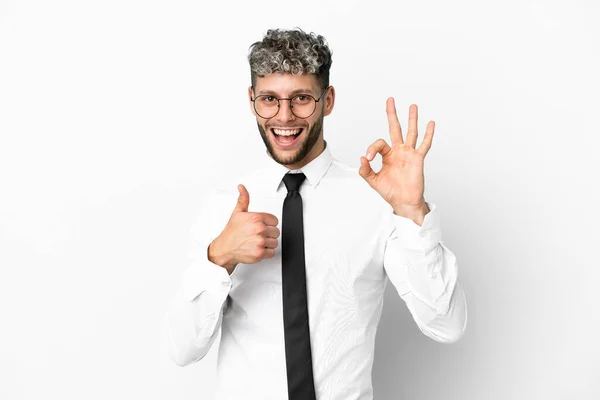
248, 28, 332, 89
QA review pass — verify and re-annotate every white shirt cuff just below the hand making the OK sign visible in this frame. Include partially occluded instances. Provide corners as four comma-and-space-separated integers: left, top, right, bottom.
392, 202, 442, 253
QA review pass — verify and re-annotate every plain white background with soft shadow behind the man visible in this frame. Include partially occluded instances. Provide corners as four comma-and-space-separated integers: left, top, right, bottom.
0, 0, 600, 400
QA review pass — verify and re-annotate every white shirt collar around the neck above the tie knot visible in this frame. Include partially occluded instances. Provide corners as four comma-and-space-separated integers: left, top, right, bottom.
261, 140, 333, 192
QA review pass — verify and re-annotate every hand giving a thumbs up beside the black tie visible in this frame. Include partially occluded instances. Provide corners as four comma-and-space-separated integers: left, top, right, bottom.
208, 184, 281, 275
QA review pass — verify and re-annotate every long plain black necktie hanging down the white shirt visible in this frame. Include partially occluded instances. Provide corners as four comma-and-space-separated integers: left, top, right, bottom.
281, 173, 316, 400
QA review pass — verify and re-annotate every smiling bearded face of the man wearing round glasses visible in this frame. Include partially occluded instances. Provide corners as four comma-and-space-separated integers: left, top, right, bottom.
249, 73, 333, 166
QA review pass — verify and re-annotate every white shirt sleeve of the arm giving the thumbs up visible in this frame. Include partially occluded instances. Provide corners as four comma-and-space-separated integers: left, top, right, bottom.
164, 190, 235, 366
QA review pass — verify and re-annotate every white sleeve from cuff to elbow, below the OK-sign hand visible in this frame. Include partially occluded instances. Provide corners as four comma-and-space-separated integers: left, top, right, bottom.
384, 202, 467, 343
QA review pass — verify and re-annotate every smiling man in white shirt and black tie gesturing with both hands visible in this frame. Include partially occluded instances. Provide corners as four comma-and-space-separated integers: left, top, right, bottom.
165, 30, 467, 400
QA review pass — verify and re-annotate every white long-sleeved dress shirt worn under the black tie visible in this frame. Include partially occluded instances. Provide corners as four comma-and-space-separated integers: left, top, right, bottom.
165, 140, 467, 400
